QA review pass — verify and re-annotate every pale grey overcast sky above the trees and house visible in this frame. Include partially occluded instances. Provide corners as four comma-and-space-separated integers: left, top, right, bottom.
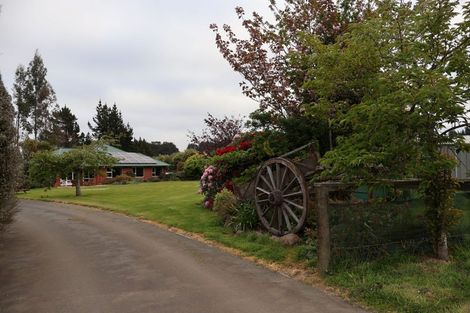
0, 0, 268, 149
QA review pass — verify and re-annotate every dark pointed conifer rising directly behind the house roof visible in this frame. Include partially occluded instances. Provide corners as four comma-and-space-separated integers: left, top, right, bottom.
88, 100, 134, 151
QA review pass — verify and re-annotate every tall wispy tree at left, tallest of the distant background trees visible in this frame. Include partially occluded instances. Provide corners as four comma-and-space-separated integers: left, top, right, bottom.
13, 50, 56, 140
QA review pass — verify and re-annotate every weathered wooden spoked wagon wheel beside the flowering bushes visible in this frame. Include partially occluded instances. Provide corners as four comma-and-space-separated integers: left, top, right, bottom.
255, 158, 309, 236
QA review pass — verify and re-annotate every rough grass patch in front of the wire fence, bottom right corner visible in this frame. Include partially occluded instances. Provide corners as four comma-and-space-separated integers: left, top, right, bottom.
326, 246, 470, 313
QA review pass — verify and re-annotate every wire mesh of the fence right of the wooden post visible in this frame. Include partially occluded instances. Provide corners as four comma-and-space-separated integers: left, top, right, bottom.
328, 189, 470, 262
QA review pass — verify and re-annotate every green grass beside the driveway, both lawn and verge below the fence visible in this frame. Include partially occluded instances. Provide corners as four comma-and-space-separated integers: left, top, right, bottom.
19, 182, 470, 313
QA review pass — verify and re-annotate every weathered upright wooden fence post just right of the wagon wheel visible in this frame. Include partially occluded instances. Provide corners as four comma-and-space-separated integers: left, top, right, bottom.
315, 185, 331, 273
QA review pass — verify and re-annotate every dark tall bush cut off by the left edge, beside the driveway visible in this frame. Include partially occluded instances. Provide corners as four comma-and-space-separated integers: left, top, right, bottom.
0, 72, 18, 230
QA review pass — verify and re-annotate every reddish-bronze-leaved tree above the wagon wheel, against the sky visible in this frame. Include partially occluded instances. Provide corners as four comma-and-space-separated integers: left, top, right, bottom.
210, 0, 369, 150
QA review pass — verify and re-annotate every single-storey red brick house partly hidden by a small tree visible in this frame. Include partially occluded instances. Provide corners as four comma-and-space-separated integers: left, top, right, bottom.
55, 145, 170, 186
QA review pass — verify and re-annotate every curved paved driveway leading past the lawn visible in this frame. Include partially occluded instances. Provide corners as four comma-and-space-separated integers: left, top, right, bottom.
0, 201, 363, 313
